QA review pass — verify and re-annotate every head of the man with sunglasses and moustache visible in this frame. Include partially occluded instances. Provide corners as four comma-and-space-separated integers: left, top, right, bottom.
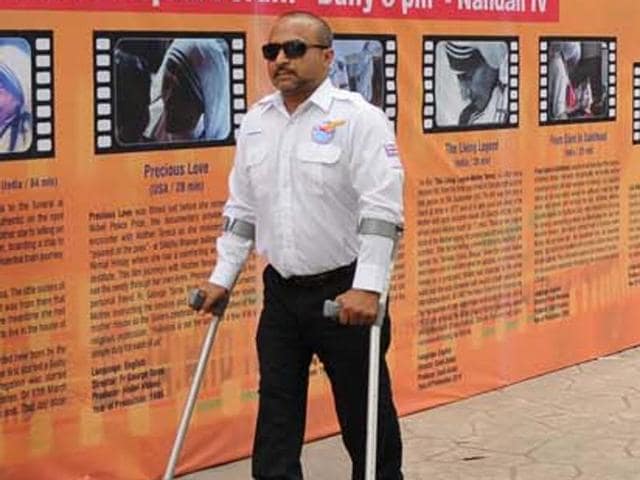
263, 12, 334, 99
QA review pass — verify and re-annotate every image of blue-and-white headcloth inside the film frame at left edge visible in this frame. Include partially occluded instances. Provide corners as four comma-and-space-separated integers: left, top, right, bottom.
0, 38, 33, 158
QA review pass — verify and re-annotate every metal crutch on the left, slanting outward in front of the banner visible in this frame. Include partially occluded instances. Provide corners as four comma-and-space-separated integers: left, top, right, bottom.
162, 289, 229, 480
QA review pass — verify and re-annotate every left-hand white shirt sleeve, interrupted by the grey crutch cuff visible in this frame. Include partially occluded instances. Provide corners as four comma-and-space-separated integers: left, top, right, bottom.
209, 124, 255, 290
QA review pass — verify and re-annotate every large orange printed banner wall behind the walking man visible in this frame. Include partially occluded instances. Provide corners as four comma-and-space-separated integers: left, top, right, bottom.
0, 0, 640, 480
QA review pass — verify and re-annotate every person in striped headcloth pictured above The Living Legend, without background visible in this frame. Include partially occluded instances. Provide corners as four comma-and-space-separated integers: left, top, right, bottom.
445, 41, 509, 126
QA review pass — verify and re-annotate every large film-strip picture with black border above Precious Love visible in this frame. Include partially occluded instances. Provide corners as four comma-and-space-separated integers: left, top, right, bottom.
94, 31, 247, 154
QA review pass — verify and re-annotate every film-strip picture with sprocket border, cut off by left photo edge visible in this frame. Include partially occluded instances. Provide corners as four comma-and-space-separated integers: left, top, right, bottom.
0, 30, 55, 160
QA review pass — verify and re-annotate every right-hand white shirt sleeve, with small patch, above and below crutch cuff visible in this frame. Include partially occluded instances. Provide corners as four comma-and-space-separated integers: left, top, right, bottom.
351, 105, 404, 293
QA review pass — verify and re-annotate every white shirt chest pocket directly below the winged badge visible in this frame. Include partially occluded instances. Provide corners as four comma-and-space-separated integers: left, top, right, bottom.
296, 142, 342, 195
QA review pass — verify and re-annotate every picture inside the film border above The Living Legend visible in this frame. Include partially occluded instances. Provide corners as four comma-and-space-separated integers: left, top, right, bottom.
436, 40, 509, 127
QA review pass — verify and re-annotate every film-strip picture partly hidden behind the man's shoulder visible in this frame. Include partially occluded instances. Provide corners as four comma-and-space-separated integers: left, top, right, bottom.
332, 34, 398, 125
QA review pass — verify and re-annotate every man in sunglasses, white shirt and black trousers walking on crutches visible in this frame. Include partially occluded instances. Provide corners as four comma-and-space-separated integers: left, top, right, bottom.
196, 12, 403, 480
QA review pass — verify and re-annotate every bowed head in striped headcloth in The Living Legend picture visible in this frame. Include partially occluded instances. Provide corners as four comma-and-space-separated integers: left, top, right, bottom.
445, 42, 506, 111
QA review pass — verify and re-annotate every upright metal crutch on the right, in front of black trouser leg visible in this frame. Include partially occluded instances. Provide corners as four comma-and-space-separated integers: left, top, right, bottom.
323, 225, 402, 480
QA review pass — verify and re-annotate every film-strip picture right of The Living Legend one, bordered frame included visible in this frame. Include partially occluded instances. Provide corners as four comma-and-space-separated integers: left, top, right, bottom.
539, 37, 617, 125
